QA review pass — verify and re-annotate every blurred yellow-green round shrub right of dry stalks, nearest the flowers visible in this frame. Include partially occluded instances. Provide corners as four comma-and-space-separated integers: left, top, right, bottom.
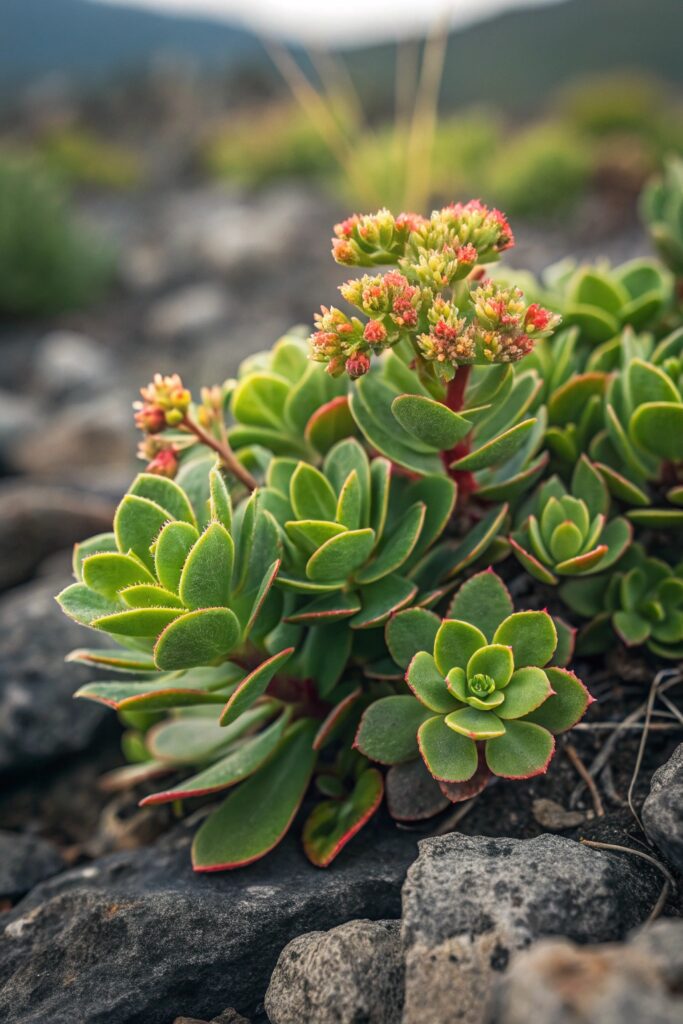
483, 122, 592, 217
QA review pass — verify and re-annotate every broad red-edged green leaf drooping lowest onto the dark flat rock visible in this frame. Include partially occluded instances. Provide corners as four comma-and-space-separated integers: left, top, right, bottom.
193, 719, 317, 871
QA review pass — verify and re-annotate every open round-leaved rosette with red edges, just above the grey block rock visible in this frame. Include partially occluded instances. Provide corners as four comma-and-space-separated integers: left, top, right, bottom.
355, 570, 591, 783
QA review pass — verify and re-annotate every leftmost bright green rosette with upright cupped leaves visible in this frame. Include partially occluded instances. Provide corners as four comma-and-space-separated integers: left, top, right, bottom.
58, 468, 281, 671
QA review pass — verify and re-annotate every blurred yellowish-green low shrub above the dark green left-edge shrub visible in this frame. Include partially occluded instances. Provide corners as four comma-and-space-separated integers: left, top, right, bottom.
39, 127, 143, 190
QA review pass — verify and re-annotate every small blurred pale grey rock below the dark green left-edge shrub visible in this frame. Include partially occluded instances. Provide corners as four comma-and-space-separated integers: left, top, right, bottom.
32, 331, 112, 400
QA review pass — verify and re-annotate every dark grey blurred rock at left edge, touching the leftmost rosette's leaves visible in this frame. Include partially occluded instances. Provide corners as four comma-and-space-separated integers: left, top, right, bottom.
0, 578, 108, 773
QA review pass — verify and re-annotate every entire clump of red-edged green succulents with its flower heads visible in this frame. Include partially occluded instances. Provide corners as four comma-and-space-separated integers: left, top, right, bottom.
54, 184, 683, 871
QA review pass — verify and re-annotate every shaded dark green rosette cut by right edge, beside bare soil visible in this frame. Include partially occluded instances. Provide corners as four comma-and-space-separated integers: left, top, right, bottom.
562, 544, 683, 659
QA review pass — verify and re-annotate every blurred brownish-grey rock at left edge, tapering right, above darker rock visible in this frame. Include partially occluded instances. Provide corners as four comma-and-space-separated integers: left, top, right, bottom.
0, 480, 115, 590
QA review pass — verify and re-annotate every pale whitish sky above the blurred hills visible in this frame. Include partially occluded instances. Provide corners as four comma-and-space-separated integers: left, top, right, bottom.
96, 0, 559, 44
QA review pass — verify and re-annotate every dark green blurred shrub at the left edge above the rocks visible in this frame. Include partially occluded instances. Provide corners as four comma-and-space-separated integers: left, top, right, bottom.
0, 154, 113, 315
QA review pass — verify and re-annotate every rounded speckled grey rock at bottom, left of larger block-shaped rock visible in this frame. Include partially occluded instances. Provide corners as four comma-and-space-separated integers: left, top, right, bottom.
265, 921, 403, 1024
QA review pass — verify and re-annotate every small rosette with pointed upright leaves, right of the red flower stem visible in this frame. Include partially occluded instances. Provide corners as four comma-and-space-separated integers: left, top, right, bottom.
510, 456, 633, 585
